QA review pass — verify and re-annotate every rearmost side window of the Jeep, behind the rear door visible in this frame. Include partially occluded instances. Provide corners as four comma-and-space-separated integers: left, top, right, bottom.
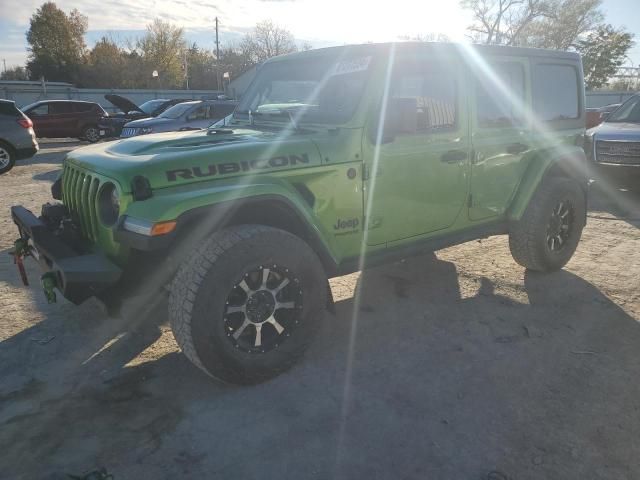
533, 64, 580, 121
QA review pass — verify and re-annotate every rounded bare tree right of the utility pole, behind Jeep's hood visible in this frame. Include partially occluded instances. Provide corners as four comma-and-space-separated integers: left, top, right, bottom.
240, 20, 298, 63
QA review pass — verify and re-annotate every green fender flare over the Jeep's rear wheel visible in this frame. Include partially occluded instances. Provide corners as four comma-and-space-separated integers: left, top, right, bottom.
507, 146, 589, 221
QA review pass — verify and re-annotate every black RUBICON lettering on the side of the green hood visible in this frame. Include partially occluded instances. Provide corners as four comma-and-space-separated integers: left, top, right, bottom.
165, 153, 309, 182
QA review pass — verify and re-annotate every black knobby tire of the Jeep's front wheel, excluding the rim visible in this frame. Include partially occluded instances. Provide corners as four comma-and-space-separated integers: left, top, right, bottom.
169, 225, 327, 384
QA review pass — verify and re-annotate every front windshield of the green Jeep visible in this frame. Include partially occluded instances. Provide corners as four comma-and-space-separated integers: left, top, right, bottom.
234, 56, 371, 124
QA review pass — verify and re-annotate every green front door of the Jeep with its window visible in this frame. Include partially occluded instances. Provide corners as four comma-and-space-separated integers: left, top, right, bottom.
364, 57, 470, 245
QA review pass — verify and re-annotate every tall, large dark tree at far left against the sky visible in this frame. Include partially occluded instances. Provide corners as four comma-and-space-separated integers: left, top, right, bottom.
27, 2, 88, 82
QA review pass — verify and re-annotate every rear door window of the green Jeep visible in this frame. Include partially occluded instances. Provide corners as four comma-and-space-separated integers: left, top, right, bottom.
476, 62, 526, 127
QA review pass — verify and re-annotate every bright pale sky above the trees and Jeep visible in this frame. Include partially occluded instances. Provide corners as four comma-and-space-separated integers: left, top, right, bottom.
0, 0, 640, 68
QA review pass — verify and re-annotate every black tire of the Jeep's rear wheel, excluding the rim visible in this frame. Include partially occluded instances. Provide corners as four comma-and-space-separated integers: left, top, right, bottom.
509, 177, 586, 272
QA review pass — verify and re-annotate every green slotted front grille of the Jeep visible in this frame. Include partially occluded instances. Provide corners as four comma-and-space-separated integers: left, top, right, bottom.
62, 163, 101, 241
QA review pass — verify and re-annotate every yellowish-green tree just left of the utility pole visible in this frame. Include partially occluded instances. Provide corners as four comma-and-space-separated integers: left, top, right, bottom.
136, 19, 186, 88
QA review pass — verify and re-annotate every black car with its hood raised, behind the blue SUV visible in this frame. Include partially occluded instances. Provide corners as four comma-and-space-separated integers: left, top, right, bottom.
98, 93, 188, 138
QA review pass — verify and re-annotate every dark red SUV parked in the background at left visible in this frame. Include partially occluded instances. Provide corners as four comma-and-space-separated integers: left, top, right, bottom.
22, 100, 109, 143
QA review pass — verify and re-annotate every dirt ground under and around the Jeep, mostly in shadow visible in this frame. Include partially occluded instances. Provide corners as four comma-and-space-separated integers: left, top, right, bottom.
0, 143, 640, 480
